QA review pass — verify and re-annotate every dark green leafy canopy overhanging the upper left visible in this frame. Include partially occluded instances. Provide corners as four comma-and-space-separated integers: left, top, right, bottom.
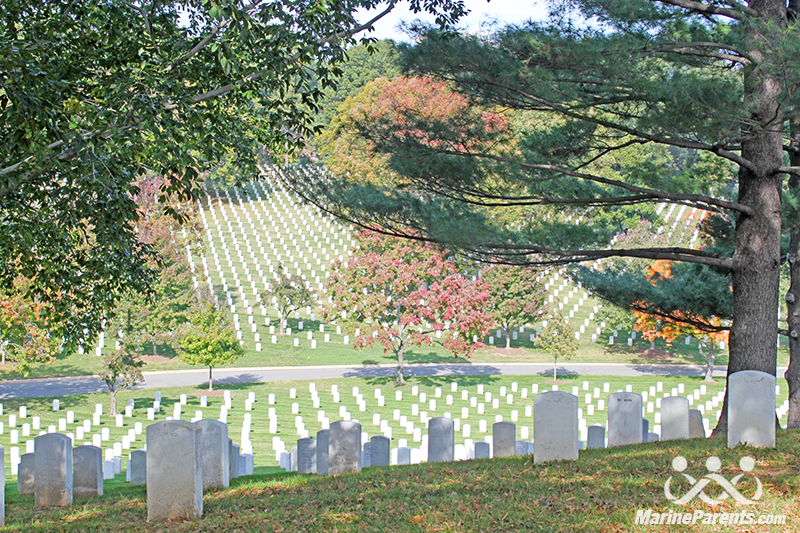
0, 0, 464, 344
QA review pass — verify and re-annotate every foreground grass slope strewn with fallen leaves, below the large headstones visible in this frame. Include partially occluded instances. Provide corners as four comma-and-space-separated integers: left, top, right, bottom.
2, 431, 800, 533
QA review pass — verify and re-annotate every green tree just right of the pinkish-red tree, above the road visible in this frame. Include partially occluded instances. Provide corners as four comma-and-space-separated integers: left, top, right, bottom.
481, 265, 547, 348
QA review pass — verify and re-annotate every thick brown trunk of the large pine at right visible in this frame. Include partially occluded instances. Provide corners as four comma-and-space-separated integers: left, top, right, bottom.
714, 0, 786, 434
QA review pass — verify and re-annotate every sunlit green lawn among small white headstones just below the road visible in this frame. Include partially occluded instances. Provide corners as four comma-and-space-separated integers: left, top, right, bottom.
0, 376, 787, 480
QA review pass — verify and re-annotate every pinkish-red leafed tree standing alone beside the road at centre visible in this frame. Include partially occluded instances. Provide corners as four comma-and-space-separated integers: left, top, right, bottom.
326, 230, 491, 386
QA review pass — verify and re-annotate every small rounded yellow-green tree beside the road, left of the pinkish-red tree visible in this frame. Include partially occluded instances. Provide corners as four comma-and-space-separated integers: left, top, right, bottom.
178, 304, 244, 390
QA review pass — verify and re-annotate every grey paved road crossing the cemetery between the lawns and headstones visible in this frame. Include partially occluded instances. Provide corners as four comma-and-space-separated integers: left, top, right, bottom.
0, 363, 786, 400
